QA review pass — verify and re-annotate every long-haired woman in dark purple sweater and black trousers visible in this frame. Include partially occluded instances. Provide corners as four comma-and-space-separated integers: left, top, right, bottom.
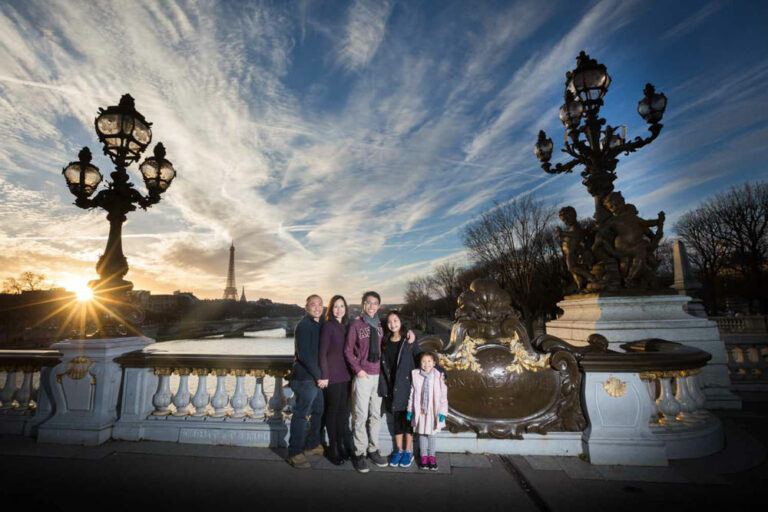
318, 295, 352, 466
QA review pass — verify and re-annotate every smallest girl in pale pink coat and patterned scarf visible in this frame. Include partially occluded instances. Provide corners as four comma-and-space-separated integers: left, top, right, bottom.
407, 352, 448, 471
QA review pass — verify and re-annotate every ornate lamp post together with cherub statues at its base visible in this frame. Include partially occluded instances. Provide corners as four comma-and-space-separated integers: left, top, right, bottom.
534, 51, 667, 292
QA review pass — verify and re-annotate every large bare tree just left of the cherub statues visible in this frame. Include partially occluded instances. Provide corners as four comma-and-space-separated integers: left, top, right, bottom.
463, 195, 562, 333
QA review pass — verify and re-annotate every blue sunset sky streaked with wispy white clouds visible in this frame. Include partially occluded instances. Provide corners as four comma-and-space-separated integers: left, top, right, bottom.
0, 0, 768, 303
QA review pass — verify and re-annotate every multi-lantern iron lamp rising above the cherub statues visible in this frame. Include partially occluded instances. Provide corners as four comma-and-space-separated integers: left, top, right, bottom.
534, 51, 667, 222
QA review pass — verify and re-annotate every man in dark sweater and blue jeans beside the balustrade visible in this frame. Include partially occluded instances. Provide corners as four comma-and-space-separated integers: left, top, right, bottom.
288, 295, 324, 469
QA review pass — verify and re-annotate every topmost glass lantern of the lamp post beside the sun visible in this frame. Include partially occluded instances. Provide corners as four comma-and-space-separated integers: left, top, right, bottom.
95, 94, 152, 165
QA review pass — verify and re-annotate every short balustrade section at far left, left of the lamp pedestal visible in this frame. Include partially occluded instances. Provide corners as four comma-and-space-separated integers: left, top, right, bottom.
0, 350, 61, 435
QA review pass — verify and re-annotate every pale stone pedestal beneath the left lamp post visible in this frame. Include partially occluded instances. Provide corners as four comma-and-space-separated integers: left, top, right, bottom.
37, 337, 154, 445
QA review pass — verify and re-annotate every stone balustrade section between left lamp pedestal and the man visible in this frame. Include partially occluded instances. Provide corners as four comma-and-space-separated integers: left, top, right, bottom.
112, 351, 293, 446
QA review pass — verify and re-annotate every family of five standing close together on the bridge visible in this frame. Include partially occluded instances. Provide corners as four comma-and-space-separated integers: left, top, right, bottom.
288, 291, 448, 473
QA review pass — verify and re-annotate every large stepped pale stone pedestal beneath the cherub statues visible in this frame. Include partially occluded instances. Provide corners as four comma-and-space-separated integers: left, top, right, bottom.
546, 295, 741, 409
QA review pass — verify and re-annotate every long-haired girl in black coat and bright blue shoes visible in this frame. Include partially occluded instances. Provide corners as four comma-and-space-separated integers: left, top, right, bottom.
379, 311, 421, 468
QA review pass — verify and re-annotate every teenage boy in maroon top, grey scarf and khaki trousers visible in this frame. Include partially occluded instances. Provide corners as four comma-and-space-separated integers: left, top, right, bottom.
344, 292, 415, 473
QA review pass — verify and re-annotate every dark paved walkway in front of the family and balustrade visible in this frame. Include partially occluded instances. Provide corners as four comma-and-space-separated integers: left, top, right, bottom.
0, 395, 768, 512
